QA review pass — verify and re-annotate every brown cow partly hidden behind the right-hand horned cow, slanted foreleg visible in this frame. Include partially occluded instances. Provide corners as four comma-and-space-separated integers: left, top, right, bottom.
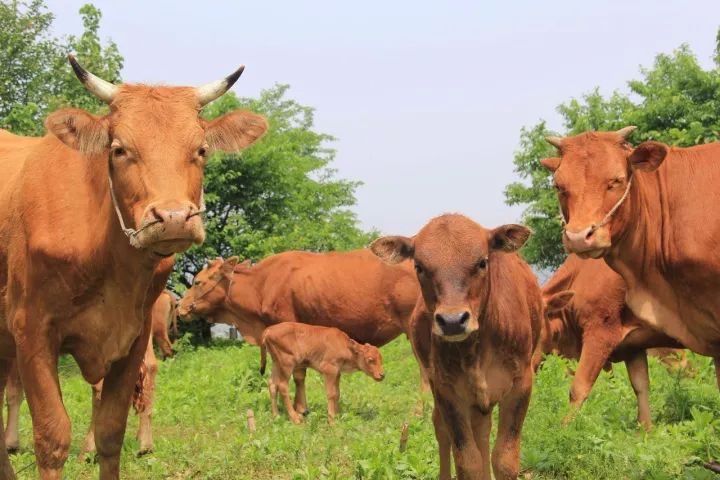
540, 255, 683, 430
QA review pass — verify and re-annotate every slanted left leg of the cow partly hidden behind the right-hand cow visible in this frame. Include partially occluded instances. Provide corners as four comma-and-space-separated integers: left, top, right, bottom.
563, 331, 620, 425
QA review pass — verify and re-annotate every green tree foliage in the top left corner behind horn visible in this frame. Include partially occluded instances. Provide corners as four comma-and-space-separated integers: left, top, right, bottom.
0, 0, 123, 135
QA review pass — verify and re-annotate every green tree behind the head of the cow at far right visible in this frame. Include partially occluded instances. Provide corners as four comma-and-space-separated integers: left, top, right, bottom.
505, 36, 720, 268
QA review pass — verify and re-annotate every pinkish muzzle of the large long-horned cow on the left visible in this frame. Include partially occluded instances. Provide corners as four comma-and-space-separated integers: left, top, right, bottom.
130, 201, 205, 256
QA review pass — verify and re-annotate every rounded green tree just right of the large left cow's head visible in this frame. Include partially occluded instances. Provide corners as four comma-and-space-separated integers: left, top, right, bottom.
174, 85, 374, 290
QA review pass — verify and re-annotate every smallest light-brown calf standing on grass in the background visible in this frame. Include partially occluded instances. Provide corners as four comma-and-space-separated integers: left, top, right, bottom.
260, 322, 385, 423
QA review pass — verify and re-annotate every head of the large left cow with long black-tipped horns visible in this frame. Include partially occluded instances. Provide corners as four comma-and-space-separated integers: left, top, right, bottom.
46, 56, 267, 257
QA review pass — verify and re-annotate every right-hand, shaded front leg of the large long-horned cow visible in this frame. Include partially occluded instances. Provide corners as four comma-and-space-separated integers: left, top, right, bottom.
95, 330, 150, 480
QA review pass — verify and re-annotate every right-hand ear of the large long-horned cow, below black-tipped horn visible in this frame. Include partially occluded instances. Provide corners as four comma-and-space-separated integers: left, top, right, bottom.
205, 110, 268, 152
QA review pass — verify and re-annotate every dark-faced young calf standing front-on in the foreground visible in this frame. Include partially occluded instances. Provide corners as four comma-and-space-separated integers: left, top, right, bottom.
371, 214, 543, 480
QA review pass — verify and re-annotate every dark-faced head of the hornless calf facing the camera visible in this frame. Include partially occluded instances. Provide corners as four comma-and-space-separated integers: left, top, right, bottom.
370, 214, 531, 341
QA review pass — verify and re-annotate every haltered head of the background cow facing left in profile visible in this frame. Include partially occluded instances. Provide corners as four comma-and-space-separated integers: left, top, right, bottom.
178, 257, 238, 321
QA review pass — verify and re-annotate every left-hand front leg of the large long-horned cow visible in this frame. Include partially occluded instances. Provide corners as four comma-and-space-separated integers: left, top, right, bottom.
15, 338, 71, 480
